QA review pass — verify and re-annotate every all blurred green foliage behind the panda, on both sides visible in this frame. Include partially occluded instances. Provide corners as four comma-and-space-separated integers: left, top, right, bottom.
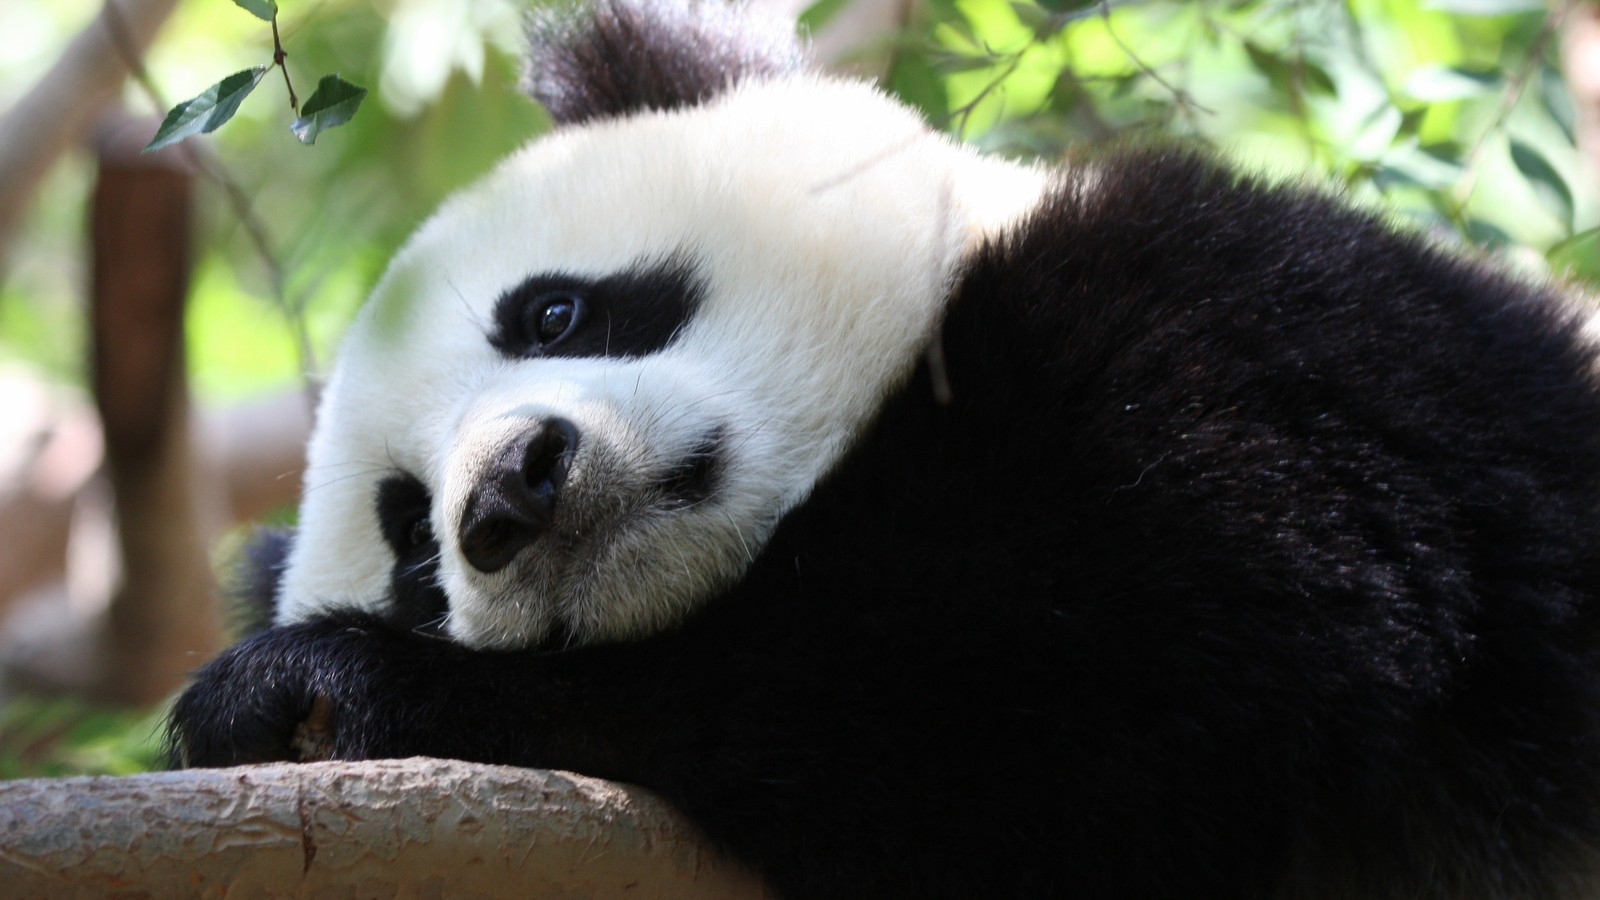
0, 0, 1600, 777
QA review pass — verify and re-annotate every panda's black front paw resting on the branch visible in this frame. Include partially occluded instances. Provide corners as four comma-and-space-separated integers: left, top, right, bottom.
166, 617, 398, 767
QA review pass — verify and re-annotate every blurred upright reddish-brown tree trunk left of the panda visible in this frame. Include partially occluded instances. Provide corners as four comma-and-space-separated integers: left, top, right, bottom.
90, 112, 221, 703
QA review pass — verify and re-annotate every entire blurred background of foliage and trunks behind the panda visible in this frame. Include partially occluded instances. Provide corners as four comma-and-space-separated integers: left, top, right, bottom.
0, 0, 1600, 777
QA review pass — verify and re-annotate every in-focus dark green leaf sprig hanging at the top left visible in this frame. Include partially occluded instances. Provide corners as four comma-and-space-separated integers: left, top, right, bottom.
144, 0, 366, 152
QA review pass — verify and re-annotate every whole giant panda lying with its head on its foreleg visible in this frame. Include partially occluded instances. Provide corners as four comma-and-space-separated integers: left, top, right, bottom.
171, 0, 1600, 900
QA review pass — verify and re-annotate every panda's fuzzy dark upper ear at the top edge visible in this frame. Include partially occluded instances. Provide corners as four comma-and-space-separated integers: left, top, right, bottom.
526, 0, 808, 125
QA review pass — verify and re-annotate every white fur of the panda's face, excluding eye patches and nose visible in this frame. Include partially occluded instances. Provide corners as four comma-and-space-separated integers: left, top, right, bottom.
280, 70, 1045, 647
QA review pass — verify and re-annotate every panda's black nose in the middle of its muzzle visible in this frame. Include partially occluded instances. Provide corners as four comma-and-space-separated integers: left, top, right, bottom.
456, 418, 578, 573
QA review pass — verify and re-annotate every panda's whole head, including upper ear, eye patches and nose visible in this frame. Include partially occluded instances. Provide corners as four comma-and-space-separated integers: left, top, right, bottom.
277, 2, 1043, 647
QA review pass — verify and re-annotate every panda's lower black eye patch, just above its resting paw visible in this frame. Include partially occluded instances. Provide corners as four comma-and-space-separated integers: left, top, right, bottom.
374, 474, 450, 631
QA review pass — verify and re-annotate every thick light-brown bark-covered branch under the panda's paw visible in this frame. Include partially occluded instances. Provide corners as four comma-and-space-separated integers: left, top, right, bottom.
0, 759, 766, 900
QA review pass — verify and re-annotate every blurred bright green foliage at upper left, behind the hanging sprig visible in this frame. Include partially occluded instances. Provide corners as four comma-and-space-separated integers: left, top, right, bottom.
0, 0, 547, 402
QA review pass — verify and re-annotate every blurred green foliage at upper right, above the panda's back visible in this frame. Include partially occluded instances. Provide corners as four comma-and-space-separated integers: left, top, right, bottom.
891, 0, 1600, 256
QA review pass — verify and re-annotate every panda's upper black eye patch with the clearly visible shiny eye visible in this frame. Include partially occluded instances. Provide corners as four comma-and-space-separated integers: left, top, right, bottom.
490, 256, 701, 359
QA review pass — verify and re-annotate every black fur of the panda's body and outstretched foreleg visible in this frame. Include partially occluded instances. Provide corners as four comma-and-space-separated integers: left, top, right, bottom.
173, 151, 1600, 898
